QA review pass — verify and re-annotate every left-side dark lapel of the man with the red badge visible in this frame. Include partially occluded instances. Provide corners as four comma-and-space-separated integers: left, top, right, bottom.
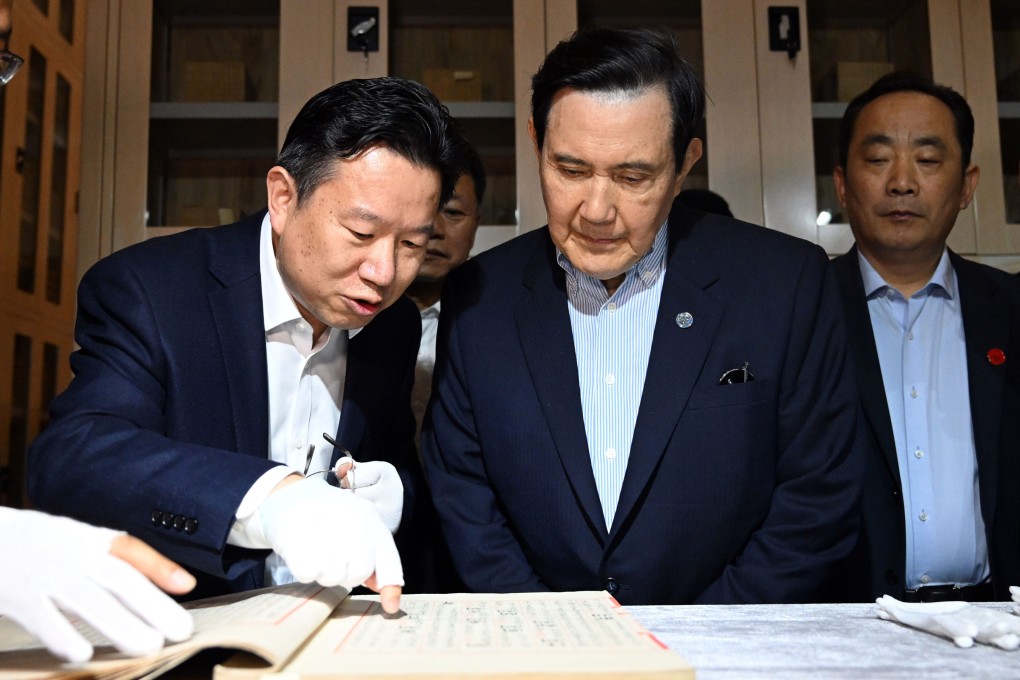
832, 246, 901, 487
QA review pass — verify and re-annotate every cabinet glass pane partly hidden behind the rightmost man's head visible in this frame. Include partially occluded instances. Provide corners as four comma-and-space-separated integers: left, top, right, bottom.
807, 0, 934, 226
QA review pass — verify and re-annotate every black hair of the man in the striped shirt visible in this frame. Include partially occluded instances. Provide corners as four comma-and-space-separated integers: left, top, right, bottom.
531, 28, 705, 172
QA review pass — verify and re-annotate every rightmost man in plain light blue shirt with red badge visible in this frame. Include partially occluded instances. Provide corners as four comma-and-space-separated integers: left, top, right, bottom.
833, 73, 1020, 601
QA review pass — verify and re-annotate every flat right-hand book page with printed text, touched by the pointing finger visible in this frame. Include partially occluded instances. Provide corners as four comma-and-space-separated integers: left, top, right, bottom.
255, 592, 695, 680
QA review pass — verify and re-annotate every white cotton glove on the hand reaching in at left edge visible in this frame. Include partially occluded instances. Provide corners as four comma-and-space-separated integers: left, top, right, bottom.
0, 508, 194, 662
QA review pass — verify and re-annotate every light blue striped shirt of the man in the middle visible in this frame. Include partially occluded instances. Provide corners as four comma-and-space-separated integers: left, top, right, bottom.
556, 225, 669, 529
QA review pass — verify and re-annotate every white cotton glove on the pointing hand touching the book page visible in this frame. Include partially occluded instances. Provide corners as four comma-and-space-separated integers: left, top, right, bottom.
257, 477, 404, 589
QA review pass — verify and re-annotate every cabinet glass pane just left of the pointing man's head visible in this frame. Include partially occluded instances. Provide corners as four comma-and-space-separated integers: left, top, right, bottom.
146, 0, 279, 226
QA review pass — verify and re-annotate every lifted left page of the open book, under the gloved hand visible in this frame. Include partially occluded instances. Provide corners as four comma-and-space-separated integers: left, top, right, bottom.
0, 583, 347, 680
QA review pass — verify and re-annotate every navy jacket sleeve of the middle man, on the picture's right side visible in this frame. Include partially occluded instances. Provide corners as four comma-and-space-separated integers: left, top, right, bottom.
697, 245, 863, 603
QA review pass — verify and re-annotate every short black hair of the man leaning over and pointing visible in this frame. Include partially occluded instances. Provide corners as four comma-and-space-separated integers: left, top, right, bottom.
276, 77, 459, 208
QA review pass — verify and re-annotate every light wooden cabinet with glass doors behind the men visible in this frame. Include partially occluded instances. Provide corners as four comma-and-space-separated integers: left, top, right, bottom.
82, 0, 1020, 275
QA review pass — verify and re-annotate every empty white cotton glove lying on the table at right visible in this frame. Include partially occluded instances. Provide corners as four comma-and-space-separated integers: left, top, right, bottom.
875, 595, 1020, 649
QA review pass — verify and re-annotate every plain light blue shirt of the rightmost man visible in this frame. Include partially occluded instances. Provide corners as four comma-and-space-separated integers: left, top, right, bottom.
858, 251, 988, 589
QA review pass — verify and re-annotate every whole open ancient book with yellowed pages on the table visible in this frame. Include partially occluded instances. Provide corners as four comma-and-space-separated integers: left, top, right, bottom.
0, 584, 695, 680
